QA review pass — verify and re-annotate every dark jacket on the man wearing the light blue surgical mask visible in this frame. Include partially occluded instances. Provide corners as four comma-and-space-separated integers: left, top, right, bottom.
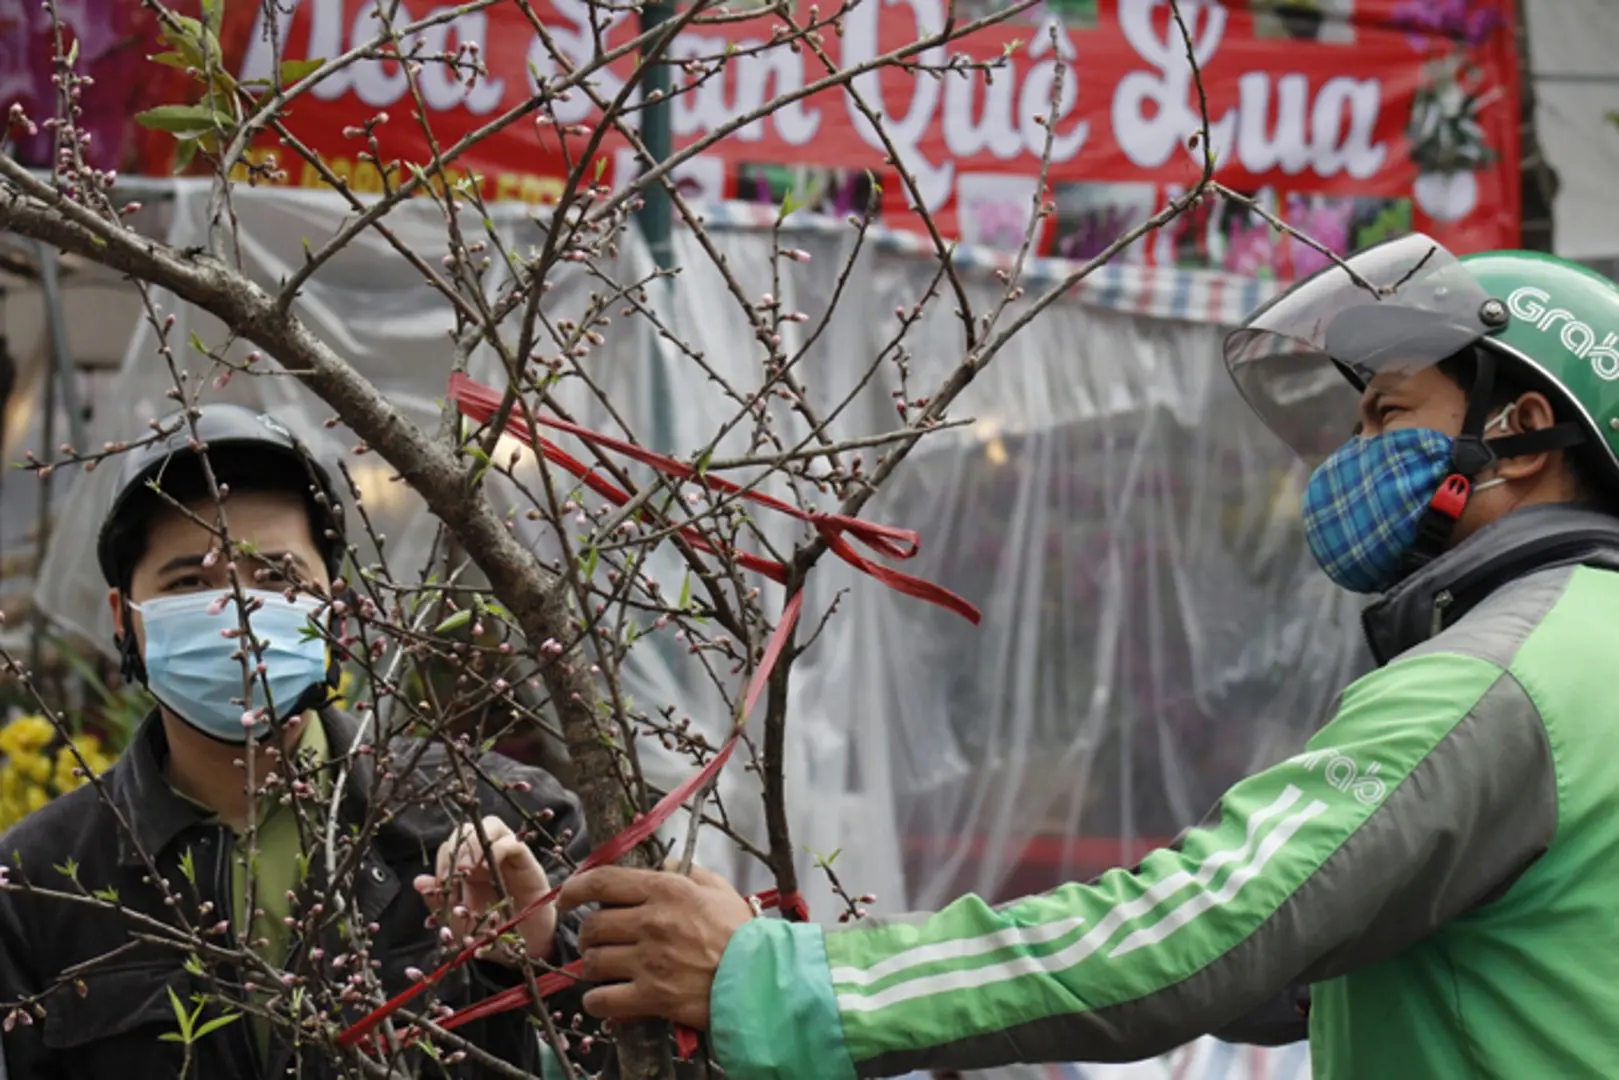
0, 709, 588, 1080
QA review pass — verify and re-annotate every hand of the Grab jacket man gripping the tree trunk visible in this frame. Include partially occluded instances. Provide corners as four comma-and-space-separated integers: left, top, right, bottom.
557, 866, 753, 1031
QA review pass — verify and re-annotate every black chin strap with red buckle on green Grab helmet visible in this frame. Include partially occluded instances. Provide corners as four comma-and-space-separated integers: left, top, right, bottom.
1400, 345, 1585, 578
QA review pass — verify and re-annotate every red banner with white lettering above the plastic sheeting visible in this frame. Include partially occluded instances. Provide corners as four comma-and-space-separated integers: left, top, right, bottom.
94, 0, 1519, 277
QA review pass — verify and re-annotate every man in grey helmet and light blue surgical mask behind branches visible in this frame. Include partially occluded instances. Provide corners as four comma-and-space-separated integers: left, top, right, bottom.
0, 405, 588, 1080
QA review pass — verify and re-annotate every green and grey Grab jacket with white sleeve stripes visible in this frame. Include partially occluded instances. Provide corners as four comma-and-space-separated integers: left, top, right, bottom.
712, 507, 1619, 1080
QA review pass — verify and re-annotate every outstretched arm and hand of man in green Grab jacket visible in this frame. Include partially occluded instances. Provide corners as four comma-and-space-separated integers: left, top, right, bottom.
563, 656, 1556, 1080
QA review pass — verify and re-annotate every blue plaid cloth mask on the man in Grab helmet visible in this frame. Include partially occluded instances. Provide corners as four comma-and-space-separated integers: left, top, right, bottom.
1303, 427, 1452, 593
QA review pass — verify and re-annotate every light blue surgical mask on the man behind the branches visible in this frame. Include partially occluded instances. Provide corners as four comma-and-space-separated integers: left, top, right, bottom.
134, 589, 327, 743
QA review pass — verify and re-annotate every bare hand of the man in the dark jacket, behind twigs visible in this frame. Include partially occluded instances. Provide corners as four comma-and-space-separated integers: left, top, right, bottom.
413, 816, 557, 965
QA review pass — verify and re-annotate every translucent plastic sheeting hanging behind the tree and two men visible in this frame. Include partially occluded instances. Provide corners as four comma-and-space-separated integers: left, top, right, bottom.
40, 185, 1365, 1080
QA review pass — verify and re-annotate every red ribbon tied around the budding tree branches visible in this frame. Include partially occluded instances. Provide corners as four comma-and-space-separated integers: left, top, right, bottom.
338, 372, 979, 1057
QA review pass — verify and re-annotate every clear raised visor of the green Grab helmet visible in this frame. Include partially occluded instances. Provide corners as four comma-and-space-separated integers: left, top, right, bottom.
1226, 233, 1493, 466
